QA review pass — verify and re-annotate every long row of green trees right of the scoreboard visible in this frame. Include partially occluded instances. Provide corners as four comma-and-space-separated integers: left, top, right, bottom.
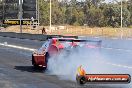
39, 0, 132, 27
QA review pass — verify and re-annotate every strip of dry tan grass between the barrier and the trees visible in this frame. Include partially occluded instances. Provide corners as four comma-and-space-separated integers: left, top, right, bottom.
3, 26, 132, 37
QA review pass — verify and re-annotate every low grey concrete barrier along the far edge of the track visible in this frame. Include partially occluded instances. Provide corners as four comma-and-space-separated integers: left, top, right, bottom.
0, 32, 78, 41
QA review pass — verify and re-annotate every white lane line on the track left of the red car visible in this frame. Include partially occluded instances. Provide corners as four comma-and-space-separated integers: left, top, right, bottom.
0, 42, 35, 51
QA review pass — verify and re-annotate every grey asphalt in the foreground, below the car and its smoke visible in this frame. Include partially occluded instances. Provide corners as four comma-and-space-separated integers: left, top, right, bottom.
0, 49, 128, 88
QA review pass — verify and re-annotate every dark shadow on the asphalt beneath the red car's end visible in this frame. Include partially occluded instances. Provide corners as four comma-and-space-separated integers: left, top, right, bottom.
14, 66, 45, 73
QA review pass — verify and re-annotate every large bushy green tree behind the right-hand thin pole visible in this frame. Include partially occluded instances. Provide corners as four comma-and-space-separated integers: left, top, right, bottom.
103, 4, 130, 27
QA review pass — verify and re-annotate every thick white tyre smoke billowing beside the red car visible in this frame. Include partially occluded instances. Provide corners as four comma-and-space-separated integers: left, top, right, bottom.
48, 48, 132, 86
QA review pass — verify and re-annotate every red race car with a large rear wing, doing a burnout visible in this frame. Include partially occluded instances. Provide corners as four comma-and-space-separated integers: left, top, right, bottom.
32, 38, 102, 68
